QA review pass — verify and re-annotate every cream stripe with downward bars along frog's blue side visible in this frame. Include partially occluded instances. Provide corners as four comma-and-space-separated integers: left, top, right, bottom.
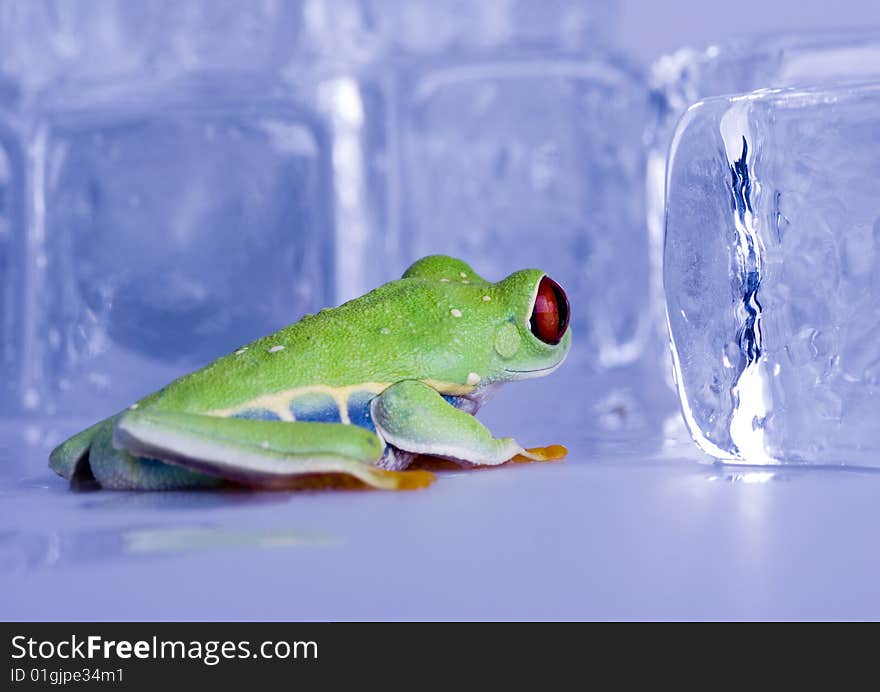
206, 379, 476, 425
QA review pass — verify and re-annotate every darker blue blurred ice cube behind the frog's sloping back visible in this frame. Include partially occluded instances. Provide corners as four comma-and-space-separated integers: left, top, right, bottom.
24, 75, 334, 415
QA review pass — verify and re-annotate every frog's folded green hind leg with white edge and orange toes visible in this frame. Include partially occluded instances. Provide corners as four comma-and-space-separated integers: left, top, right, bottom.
113, 409, 434, 490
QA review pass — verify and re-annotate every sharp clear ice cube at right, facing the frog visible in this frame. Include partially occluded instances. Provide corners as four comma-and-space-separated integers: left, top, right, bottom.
664, 85, 880, 466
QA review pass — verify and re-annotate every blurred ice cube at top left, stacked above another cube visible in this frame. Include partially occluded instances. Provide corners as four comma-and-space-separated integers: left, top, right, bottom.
0, 0, 324, 89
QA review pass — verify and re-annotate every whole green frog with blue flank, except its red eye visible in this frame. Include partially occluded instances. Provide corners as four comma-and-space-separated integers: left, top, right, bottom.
49, 255, 571, 490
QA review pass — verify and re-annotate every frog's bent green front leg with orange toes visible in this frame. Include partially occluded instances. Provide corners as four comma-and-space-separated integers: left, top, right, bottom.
370, 380, 566, 466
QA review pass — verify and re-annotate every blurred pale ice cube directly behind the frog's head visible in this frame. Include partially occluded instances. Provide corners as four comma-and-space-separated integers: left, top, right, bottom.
391, 59, 650, 369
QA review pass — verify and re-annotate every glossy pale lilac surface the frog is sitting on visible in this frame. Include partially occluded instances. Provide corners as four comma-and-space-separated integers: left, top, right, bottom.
0, 378, 880, 620
